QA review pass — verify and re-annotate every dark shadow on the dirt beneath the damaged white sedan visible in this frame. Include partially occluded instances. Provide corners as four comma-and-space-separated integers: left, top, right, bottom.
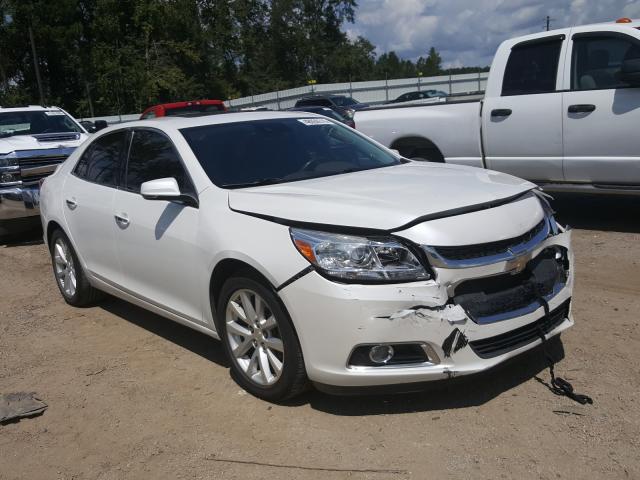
100, 297, 564, 416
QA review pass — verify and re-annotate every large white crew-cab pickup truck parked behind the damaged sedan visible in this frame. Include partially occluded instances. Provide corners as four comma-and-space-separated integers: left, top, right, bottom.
355, 18, 640, 194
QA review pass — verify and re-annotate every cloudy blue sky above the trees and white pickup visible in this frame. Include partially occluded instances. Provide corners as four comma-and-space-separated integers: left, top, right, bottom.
344, 0, 640, 67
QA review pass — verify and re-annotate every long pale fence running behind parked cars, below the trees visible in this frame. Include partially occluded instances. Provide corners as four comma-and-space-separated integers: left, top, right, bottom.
225, 72, 489, 110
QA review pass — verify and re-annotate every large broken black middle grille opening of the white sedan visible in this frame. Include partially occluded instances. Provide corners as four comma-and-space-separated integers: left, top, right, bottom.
453, 246, 568, 323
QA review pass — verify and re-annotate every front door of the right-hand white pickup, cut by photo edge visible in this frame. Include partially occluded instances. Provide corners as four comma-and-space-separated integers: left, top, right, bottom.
562, 27, 640, 186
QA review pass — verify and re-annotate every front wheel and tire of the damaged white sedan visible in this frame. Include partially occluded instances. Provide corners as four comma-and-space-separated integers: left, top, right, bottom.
217, 274, 308, 402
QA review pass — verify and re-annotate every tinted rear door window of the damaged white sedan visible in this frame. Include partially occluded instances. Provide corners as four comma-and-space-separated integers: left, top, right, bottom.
73, 130, 128, 187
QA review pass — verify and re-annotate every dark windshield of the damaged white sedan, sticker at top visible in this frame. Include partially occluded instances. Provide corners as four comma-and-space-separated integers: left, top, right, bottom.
181, 118, 402, 188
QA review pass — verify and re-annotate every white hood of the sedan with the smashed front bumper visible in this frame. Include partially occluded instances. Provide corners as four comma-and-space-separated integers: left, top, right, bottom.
229, 162, 535, 230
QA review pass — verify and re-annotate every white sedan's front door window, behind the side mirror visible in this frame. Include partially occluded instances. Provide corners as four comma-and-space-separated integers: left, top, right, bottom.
125, 130, 195, 194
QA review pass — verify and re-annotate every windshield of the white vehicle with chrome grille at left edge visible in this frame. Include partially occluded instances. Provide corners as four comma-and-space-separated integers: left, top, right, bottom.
0, 110, 81, 137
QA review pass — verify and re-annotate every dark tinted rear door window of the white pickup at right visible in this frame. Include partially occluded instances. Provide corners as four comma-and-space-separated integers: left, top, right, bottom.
502, 37, 564, 96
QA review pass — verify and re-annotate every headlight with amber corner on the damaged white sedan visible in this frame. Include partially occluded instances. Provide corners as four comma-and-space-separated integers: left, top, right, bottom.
290, 228, 430, 282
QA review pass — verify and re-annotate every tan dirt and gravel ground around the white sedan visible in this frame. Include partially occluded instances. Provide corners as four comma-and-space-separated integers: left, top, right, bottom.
0, 196, 640, 479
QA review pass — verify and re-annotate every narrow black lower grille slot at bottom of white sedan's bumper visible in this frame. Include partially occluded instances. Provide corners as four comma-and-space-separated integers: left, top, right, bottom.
469, 299, 571, 358
